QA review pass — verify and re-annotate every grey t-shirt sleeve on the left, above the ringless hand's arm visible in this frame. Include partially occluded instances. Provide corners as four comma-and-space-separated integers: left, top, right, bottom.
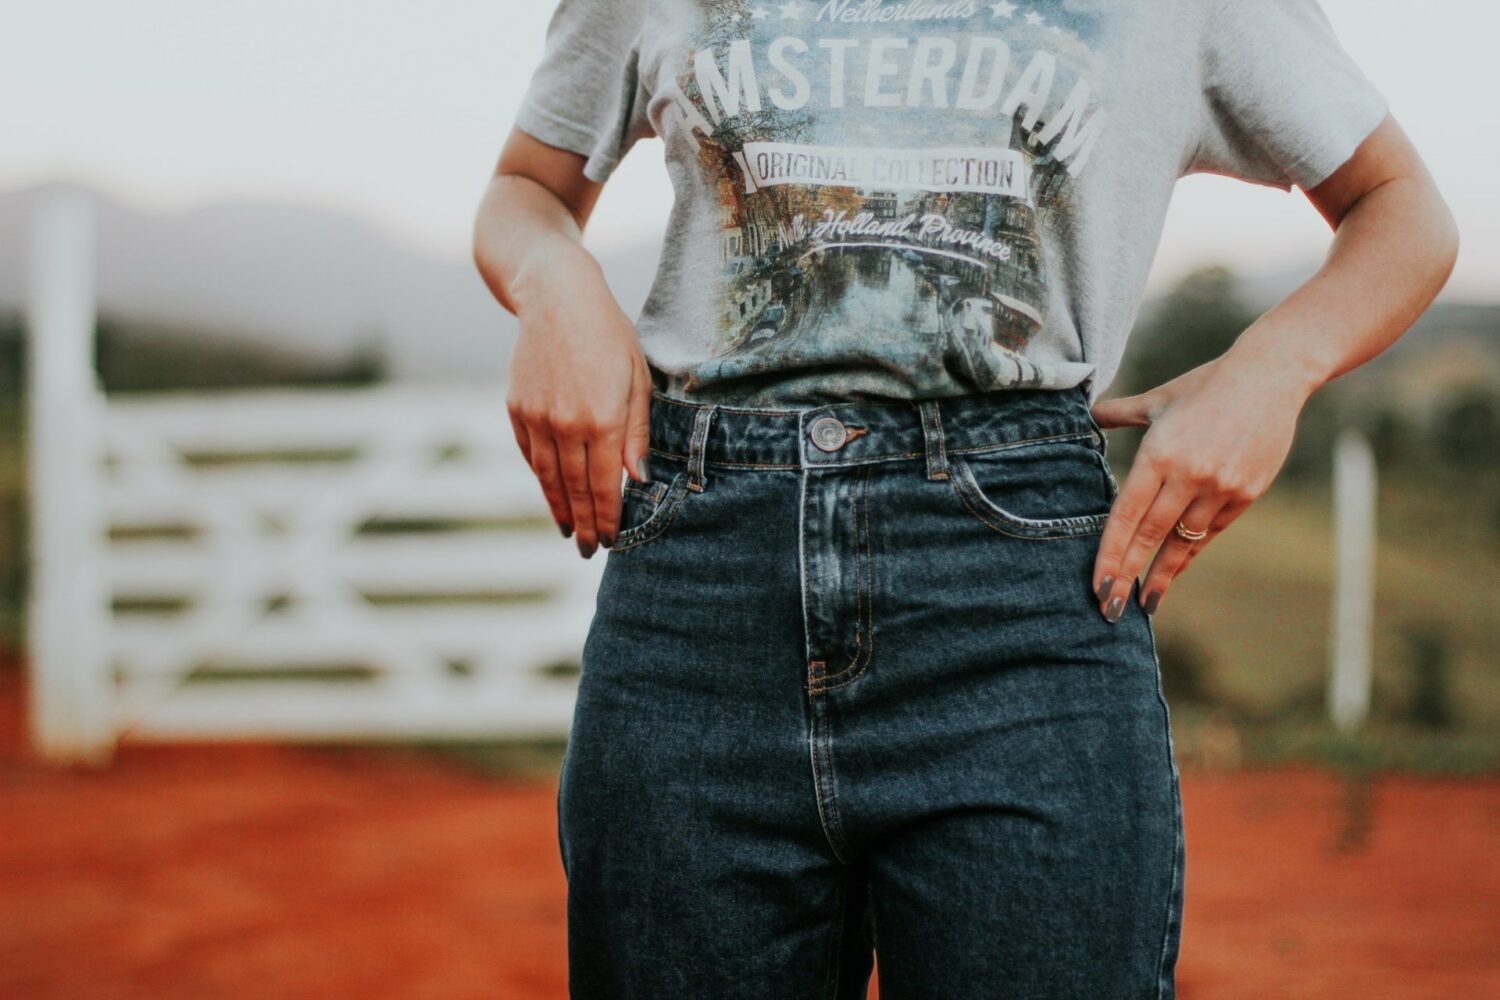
516, 0, 653, 183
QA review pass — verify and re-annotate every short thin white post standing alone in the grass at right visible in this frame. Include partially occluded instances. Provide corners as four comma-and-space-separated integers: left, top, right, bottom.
1328, 427, 1376, 732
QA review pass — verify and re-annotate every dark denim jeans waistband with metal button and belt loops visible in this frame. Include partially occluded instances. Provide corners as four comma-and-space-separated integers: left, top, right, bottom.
651, 385, 1104, 484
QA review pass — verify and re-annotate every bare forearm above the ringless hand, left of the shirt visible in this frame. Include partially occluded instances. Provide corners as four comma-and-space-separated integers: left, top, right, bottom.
474, 174, 603, 315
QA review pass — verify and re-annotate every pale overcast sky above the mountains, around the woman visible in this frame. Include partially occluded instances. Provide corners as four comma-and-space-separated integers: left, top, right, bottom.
0, 0, 1500, 300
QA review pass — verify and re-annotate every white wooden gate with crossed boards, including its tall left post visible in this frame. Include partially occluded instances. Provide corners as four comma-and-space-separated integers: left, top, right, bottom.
29, 193, 605, 759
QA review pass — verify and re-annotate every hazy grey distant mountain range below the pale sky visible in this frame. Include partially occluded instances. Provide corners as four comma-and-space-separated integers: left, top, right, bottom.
0, 183, 1500, 379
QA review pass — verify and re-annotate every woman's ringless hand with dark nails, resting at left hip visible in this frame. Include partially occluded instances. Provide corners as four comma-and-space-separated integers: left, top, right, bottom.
506, 247, 651, 559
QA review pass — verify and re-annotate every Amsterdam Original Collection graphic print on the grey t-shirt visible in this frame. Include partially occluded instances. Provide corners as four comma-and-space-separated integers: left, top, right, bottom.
674, 0, 1106, 400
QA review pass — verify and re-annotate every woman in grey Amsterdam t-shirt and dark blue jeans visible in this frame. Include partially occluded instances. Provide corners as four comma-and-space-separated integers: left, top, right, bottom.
474, 0, 1458, 1000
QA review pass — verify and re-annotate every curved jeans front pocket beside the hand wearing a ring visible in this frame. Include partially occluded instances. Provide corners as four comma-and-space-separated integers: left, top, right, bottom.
948, 435, 1115, 538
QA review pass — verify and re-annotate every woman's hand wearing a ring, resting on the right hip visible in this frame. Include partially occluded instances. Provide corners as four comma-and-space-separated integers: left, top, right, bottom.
1092, 355, 1310, 622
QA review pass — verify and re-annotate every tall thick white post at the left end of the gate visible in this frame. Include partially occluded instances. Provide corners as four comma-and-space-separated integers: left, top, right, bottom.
27, 192, 114, 763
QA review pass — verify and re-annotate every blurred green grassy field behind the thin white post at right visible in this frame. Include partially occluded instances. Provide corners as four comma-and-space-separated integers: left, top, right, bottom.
1157, 470, 1500, 736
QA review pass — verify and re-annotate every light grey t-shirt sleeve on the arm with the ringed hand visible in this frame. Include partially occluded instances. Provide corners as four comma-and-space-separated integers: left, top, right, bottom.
1184, 0, 1389, 190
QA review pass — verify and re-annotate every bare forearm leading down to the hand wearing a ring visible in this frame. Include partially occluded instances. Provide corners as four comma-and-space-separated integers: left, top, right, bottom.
1224, 177, 1458, 399
